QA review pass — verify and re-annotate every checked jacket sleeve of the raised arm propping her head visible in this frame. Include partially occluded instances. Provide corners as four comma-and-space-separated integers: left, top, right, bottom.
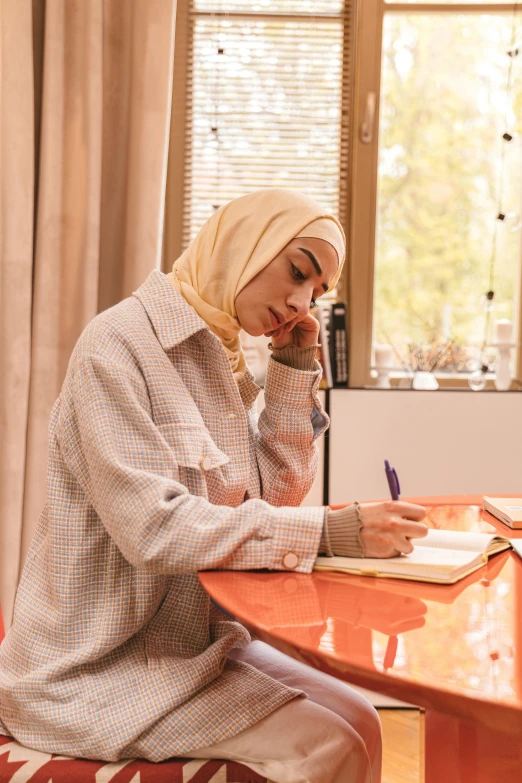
251, 358, 329, 506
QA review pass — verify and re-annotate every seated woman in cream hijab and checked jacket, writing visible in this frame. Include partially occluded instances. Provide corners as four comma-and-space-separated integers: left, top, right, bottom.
0, 190, 425, 783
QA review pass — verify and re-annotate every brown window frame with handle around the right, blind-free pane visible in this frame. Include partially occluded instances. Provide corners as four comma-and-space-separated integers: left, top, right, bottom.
348, 0, 522, 389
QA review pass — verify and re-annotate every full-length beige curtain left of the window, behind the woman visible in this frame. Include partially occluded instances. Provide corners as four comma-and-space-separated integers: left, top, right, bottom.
0, 0, 176, 626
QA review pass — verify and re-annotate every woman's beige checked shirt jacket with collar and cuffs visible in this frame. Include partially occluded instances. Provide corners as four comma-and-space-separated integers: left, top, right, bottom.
0, 272, 327, 761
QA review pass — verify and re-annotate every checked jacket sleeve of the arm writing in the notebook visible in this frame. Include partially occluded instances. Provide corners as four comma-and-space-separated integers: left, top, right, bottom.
59, 357, 324, 574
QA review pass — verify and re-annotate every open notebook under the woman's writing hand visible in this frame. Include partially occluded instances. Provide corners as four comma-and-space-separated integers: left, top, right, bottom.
314, 530, 522, 585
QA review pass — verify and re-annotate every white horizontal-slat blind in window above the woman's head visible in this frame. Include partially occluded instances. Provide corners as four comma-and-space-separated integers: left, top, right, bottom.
182, 0, 352, 247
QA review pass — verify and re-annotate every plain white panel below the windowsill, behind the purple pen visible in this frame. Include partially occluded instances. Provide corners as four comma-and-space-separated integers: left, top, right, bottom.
329, 389, 522, 503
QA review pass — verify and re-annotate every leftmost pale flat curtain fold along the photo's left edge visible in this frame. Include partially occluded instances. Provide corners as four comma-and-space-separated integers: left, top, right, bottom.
0, 0, 34, 624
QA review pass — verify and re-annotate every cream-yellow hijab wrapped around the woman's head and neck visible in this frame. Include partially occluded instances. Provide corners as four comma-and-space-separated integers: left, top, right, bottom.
168, 188, 345, 381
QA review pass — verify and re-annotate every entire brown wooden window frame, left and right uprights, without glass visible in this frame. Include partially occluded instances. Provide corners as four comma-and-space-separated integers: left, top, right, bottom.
162, 0, 522, 388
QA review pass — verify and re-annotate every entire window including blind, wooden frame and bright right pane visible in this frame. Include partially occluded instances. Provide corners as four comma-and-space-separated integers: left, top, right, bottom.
164, 0, 522, 387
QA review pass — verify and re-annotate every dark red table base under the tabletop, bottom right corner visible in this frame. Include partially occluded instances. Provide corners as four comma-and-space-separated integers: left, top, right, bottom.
424, 710, 522, 783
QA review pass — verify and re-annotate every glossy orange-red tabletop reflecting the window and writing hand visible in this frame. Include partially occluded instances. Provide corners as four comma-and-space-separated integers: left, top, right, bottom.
201, 505, 522, 704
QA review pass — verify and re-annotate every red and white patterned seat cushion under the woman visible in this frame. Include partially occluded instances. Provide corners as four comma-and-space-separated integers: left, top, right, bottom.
0, 736, 268, 783
